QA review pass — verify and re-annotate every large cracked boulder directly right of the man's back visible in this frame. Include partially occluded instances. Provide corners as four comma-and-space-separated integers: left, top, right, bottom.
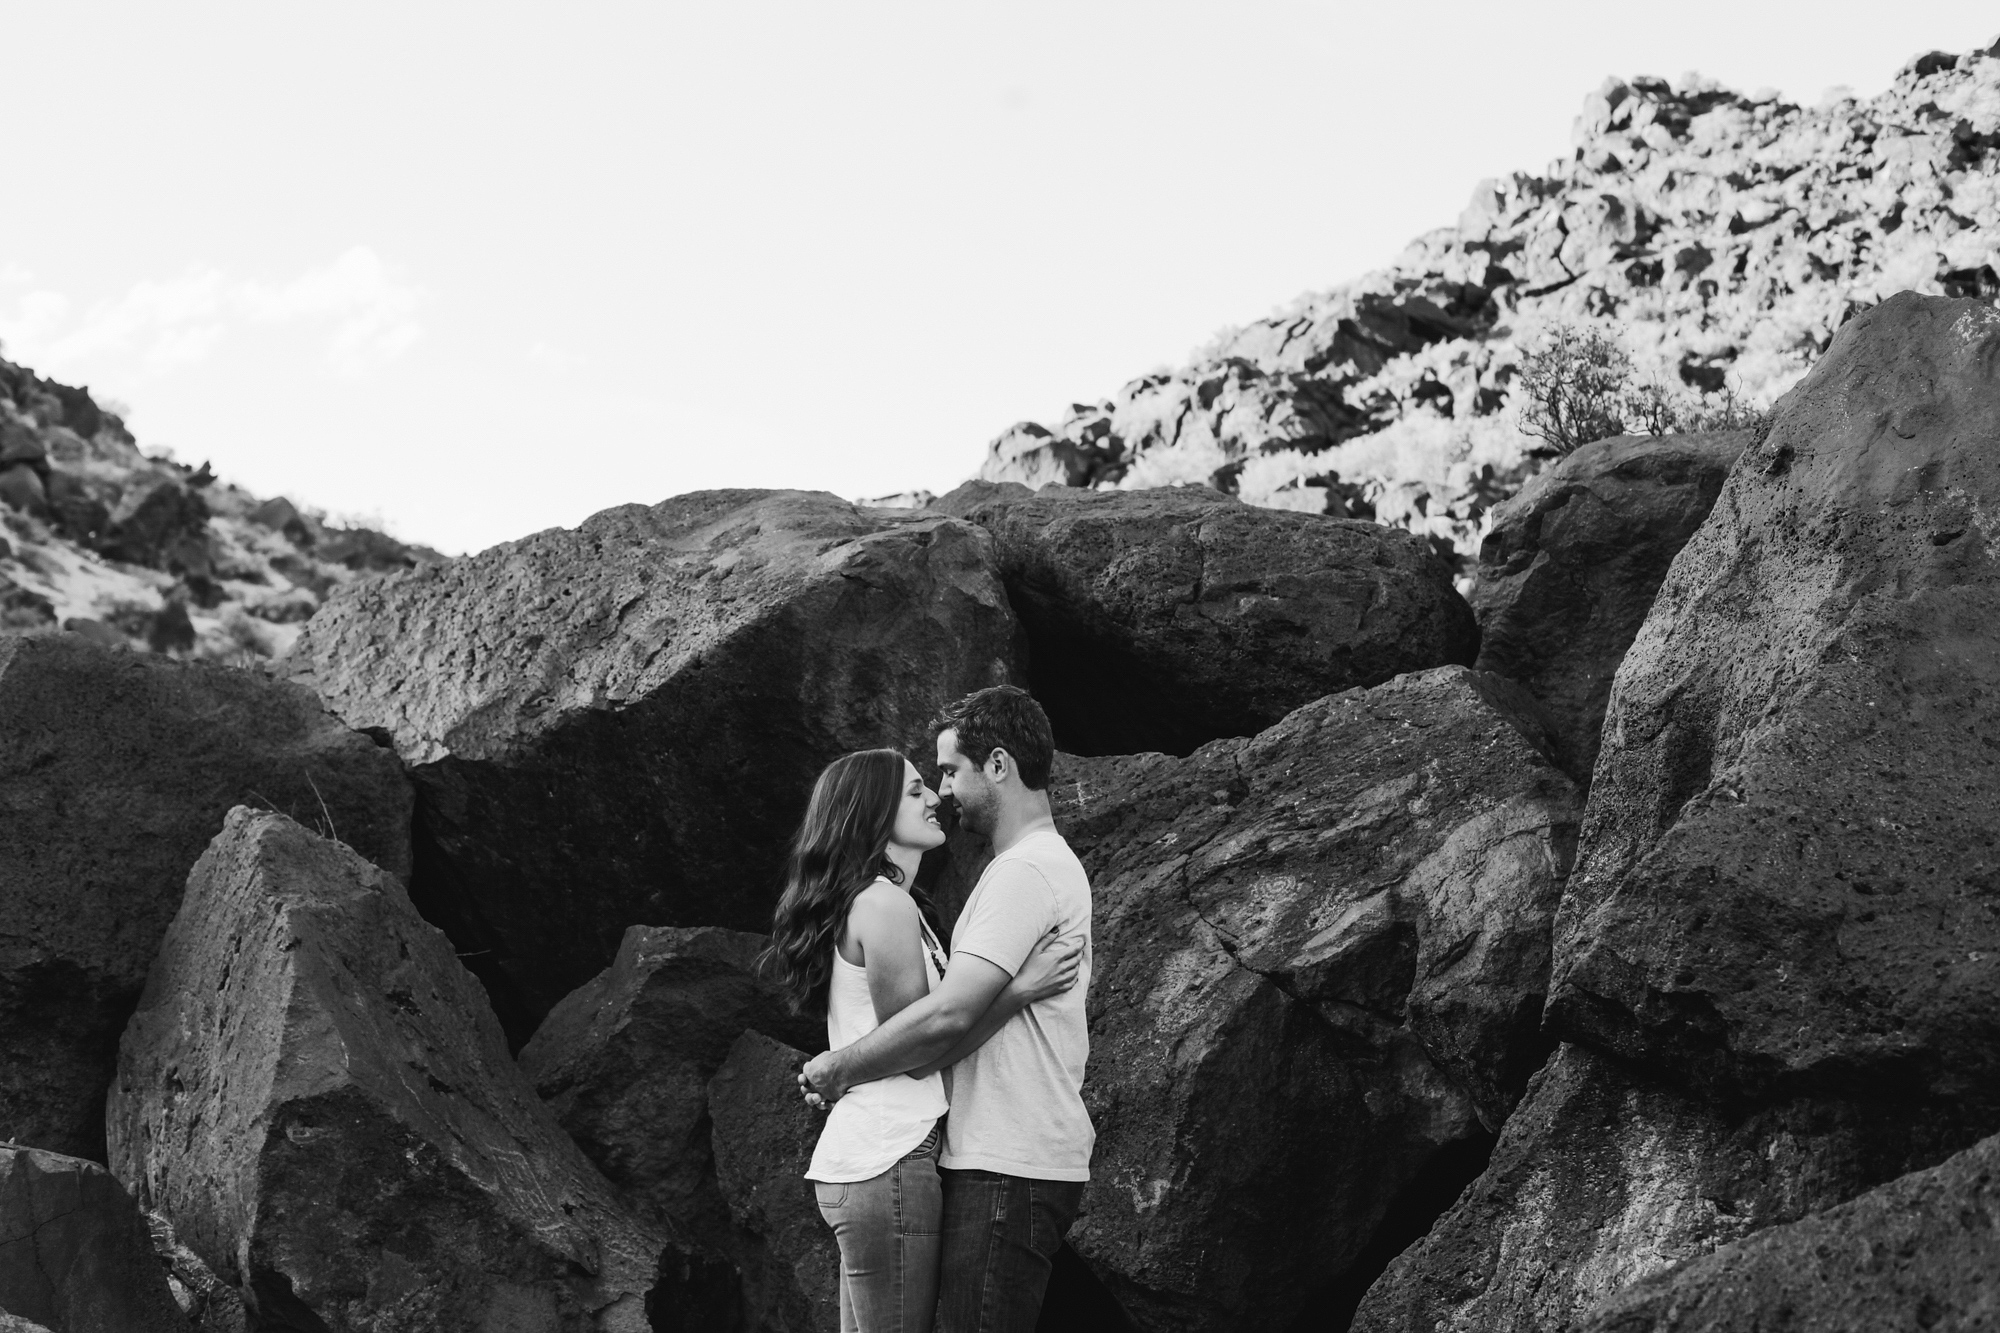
1052, 667, 1576, 1331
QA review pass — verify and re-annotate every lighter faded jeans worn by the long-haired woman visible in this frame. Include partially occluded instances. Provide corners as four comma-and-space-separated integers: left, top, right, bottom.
814, 1129, 944, 1333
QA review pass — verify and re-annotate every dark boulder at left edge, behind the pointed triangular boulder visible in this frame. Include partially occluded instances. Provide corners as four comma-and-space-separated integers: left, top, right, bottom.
0, 634, 410, 1159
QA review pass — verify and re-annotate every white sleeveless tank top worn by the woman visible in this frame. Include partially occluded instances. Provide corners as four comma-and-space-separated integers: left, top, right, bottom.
806, 881, 948, 1185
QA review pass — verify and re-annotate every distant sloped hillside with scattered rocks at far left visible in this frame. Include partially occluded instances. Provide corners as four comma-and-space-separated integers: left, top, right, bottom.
0, 360, 442, 660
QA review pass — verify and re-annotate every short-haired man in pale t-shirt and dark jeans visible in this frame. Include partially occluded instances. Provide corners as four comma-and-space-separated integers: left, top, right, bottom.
800, 685, 1096, 1333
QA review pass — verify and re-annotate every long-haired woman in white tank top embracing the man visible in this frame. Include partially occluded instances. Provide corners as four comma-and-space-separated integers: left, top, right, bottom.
764, 751, 1078, 1333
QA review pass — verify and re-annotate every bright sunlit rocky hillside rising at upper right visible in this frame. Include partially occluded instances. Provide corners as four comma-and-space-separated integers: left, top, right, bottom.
980, 46, 2000, 554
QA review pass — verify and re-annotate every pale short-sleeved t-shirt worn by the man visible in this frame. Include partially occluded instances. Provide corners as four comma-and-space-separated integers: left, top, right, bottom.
938, 831, 1098, 1181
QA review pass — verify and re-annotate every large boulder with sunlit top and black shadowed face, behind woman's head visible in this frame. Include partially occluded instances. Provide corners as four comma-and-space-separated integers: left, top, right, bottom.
294, 490, 1016, 1041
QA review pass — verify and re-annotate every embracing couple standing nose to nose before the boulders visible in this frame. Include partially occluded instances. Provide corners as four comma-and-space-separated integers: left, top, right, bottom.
766, 687, 1094, 1333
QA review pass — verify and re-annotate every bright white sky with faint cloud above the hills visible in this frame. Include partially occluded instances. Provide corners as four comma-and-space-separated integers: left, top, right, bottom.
0, 0, 2000, 550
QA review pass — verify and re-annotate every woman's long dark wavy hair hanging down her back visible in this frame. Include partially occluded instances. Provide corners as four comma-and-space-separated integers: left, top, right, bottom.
758, 751, 922, 1015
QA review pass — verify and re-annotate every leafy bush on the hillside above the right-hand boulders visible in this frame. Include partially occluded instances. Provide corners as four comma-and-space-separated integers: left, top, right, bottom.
1514, 324, 1770, 458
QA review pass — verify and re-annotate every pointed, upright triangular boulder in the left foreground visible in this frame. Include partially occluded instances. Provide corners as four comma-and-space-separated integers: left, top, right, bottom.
106, 809, 704, 1333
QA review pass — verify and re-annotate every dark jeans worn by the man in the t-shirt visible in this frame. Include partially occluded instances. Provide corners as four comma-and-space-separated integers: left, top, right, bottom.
938, 1167, 1084, 1333
